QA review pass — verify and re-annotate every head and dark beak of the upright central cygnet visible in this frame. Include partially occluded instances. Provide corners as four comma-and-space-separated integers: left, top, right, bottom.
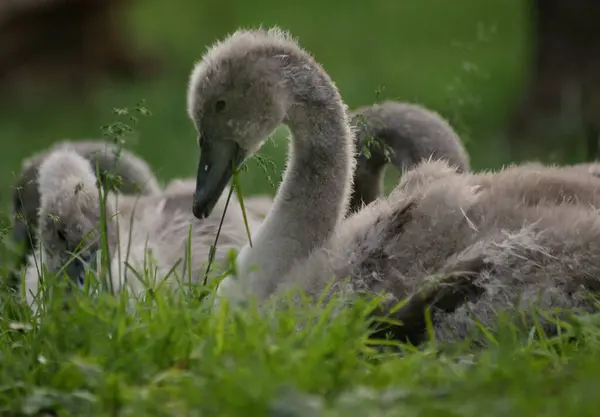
187, 28, 326, 218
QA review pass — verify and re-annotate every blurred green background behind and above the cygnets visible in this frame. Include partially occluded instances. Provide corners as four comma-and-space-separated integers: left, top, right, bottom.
0, 0, 529, 203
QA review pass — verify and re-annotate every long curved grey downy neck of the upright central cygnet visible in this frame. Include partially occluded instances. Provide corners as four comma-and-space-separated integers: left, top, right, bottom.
232, 62, 354, 298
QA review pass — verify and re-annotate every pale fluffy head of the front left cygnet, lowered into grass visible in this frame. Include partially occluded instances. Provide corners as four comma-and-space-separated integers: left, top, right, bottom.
38, 149, 115, 285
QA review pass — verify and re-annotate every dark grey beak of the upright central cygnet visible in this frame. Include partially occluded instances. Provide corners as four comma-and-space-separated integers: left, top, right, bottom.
192, 140, 244, 219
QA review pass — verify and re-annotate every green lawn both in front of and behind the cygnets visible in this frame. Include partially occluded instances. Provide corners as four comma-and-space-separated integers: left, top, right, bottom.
0, 0, 600, 417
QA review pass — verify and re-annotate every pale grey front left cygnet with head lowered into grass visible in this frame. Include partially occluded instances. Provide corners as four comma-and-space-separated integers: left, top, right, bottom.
27, 149, 268, 302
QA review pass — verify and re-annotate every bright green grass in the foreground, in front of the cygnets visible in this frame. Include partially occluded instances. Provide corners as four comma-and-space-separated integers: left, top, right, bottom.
0, 274, 600, 417
